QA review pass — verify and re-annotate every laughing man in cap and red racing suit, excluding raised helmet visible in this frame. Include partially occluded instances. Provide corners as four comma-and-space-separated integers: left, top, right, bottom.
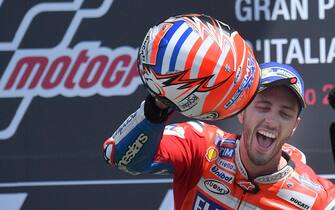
103, 13, 335, 210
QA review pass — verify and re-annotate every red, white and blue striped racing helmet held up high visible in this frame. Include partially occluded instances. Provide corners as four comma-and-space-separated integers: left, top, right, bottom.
138, 14, 261, 120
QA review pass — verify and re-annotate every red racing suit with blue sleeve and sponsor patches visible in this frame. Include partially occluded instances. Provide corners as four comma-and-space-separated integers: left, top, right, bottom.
103, 103, 335, 210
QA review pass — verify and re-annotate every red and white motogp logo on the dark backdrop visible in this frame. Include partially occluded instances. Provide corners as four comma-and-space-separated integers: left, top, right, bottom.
0, 0, 141, 140
